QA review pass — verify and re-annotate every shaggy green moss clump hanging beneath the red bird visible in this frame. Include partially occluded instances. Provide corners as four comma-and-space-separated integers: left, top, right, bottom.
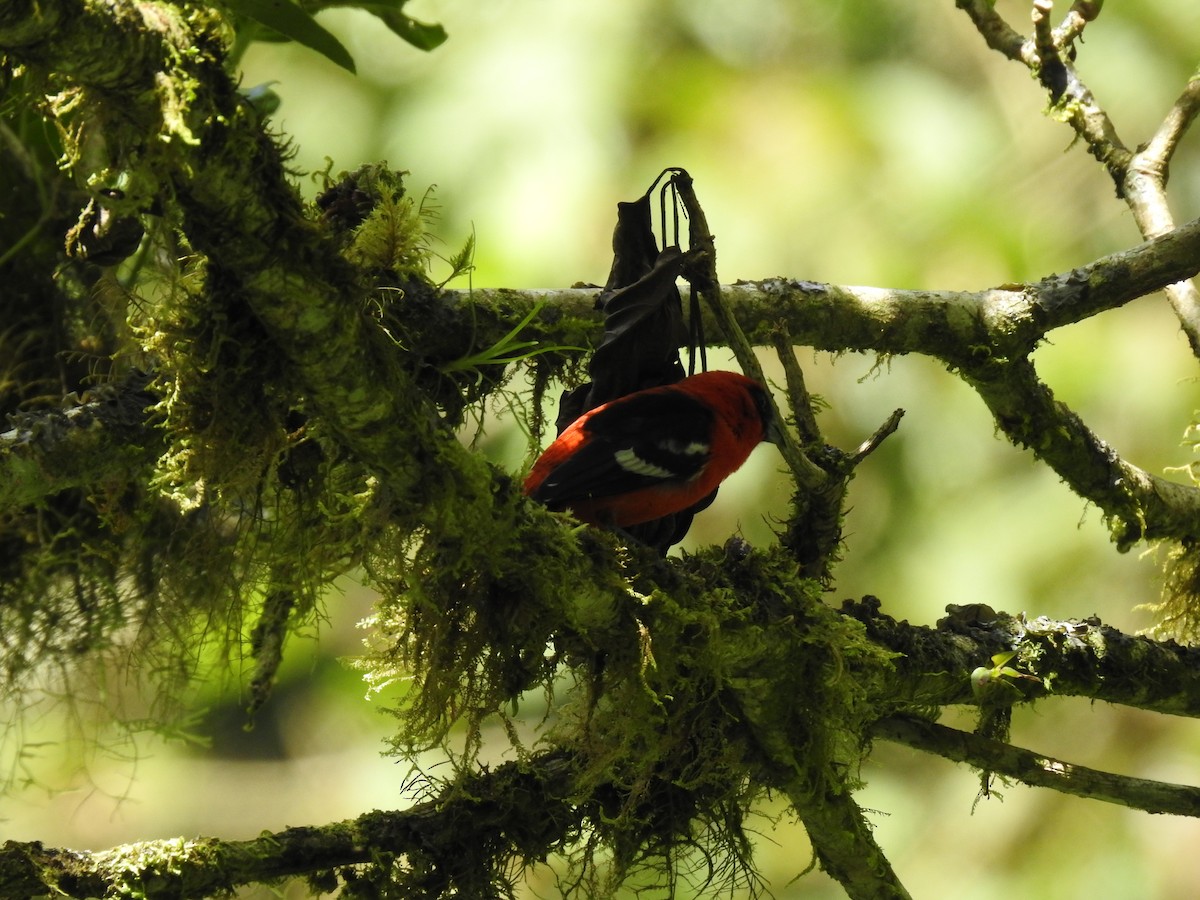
364, 528, 893, 895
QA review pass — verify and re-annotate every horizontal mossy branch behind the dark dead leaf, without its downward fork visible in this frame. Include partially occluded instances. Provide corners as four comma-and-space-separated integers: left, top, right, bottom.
445, 213, 1200, 366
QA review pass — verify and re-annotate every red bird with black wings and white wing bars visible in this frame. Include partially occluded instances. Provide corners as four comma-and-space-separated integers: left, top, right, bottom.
524, 372, 779, 528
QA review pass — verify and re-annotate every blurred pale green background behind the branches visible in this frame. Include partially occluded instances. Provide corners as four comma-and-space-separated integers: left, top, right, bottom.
7, 0, 1200, 900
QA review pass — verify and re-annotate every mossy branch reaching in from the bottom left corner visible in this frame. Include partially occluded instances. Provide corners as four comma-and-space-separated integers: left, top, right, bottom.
0, 754, 584, 900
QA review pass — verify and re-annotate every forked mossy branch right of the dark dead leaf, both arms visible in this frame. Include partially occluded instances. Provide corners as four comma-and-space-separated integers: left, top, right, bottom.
444, 221, 1200, 548
